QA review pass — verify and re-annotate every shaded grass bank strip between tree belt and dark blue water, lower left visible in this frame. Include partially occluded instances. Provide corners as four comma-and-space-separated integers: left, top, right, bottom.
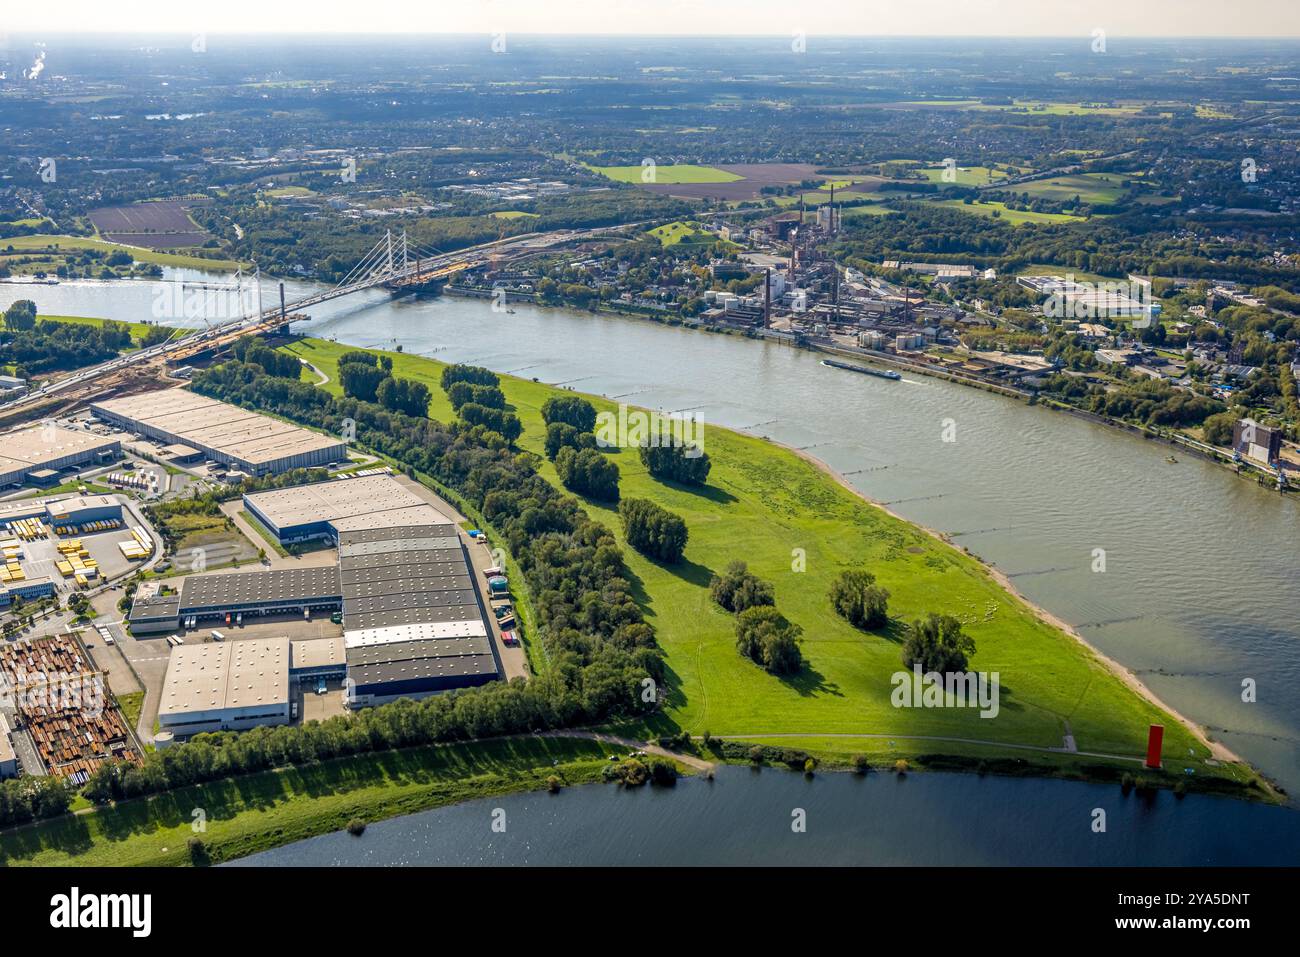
0, 739, 624, 867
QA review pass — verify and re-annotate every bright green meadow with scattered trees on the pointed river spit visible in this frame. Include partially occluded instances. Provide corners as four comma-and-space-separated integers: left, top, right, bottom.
286, 339, 1242, 775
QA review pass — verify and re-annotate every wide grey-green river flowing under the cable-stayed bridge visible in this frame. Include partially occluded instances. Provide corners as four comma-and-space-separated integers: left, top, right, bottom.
0, 270, 1300, 859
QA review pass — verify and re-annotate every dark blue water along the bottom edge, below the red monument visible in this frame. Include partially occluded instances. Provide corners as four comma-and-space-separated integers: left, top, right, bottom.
231, 767, 1300, 867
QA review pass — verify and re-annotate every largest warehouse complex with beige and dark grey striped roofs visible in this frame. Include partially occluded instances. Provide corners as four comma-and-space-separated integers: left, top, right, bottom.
127, 475, 501, 712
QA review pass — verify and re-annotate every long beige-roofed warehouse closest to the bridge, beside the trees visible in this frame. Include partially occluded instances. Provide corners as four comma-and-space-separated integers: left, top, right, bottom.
90, 389, 347, 476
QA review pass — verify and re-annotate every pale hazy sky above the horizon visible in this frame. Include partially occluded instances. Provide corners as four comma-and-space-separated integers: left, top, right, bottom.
0, 0, 1300, 36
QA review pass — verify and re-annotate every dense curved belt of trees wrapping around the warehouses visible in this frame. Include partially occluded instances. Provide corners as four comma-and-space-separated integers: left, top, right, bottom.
47, 361, 664, 816
